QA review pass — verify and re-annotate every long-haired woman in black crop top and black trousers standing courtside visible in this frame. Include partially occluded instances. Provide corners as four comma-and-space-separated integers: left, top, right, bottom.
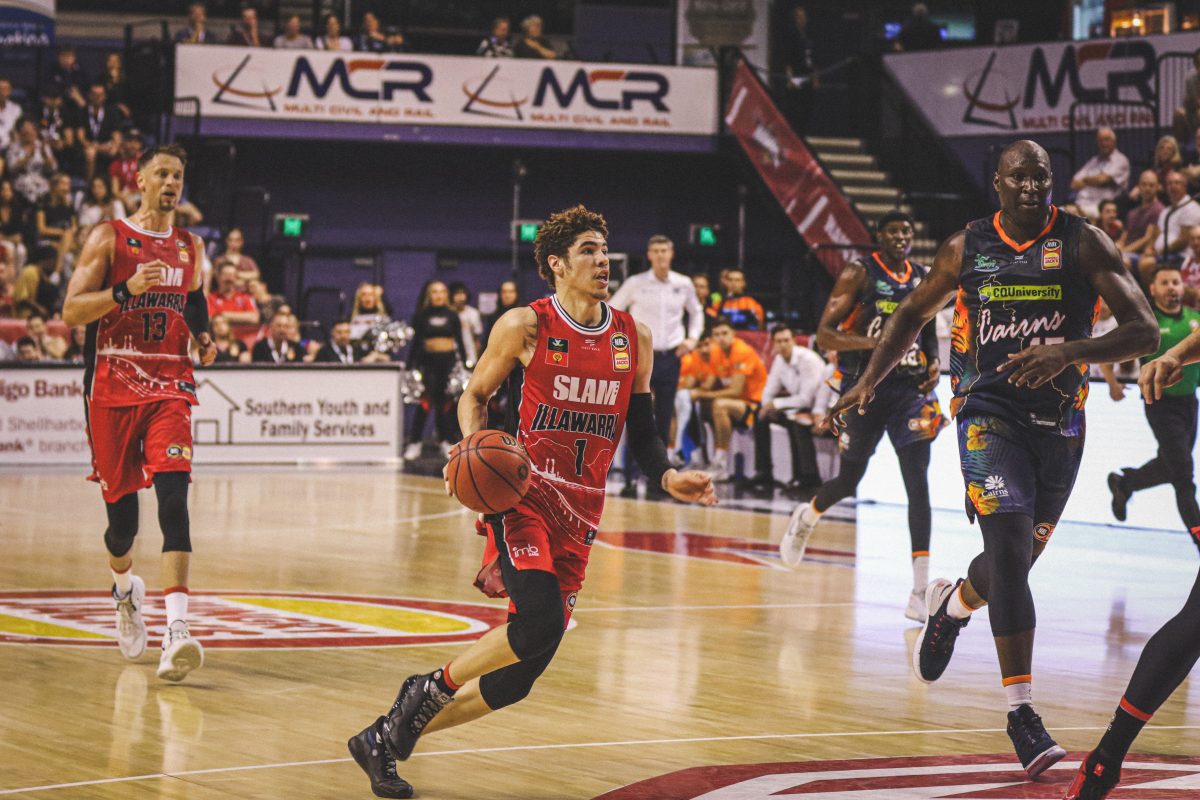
404, 281, 466, 461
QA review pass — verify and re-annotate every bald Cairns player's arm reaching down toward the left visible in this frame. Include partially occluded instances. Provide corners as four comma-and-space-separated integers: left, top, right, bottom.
829, 230, 966, 424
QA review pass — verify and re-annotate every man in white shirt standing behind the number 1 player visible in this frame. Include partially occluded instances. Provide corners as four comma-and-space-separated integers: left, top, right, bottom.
608, 234, 704, 497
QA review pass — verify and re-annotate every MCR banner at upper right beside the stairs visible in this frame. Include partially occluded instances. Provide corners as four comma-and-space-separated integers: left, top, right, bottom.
883, 34, 1200, 137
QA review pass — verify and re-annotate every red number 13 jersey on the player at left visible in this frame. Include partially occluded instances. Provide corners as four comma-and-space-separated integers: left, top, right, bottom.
84, 219, 197, 407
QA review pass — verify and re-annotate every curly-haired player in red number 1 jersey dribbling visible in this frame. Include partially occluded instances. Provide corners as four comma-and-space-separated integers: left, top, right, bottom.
348, 206, 716, 798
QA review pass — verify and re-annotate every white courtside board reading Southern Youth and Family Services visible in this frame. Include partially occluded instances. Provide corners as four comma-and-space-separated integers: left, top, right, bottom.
0, 367, 404, 467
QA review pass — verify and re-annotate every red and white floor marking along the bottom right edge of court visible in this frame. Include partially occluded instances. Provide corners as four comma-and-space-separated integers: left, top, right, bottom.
594, 753, 1200, 800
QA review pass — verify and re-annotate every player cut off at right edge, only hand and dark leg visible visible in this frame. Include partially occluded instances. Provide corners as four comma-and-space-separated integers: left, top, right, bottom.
1066, 321, 1200, 800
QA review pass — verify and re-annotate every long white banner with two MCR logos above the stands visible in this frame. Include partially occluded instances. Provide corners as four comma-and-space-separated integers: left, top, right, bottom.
175, 44, 716, 136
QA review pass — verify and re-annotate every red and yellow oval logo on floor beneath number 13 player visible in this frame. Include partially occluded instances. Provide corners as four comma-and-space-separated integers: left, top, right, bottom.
0, 589, 506, 650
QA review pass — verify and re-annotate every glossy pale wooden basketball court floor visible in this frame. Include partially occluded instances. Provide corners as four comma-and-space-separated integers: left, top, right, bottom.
0, 468, 1200, 800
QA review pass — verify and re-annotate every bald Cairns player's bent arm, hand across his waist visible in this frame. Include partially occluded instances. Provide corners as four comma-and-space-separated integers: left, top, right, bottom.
998, 225, 1158, 389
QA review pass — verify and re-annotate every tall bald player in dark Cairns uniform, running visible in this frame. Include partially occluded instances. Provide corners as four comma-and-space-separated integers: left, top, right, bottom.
830, 140, 1158, 777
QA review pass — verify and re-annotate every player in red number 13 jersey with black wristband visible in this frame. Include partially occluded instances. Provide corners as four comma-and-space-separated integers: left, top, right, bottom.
62, 145, 217, 681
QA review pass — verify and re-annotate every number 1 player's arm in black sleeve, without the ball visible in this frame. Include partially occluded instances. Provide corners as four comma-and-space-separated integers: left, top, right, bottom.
626, 323, 716, 505
